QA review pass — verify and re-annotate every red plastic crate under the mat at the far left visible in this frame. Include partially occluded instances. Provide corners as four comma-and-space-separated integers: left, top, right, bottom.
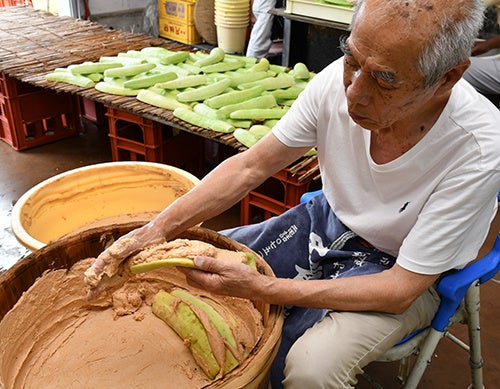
0, 73, 81, 150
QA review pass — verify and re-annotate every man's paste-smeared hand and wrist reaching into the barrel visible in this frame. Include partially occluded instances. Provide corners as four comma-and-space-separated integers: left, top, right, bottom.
85, 223, 165, 299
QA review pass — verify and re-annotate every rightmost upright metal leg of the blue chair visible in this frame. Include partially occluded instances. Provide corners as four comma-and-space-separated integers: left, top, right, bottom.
465, 283, 483, 389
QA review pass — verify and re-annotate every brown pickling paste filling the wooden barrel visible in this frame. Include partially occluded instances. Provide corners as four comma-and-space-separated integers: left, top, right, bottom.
0, 241, 262, 389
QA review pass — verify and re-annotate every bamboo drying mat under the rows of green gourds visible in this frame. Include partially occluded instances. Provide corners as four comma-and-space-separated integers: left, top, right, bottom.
0, 6, 317, 176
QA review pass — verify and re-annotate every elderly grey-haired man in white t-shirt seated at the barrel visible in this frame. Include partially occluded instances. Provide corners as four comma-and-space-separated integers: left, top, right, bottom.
86, 0, 500, 389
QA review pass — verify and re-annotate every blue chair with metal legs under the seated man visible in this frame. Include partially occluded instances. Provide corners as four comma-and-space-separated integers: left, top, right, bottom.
300, 190, 500, 389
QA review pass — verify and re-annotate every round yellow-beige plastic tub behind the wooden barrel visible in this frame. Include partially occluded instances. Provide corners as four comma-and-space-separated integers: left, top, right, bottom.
11, 161, 199, 251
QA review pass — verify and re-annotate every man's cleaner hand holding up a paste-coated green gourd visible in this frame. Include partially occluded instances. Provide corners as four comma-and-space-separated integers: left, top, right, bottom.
179, 256, 268, 300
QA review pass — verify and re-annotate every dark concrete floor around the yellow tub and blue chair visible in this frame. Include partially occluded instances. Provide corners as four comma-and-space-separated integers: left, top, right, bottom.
0, 119, 500, 389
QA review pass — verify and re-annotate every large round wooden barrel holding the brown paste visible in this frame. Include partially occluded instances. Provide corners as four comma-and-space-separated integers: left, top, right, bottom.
0, 222, 283, 389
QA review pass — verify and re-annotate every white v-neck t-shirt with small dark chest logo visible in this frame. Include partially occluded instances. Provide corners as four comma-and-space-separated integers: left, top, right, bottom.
273, 58, 500, 274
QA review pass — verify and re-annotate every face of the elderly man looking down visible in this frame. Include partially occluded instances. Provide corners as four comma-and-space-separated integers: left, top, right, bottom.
343, 2, 435, 130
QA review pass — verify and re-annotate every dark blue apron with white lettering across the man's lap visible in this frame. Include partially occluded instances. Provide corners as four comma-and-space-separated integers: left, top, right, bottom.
221, 194, 396, 389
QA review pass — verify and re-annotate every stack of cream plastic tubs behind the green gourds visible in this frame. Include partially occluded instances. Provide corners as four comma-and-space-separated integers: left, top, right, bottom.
214, 0, 250, 54
